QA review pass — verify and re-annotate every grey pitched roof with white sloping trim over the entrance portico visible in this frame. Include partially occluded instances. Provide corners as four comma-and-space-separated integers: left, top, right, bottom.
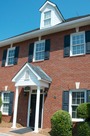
12, 63, 52, 83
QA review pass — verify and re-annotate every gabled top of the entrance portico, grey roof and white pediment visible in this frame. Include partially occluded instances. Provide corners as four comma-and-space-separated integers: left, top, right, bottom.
12, 63, 52, 86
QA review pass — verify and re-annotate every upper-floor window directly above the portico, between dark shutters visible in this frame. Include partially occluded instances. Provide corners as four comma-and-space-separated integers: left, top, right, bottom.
34, 40, 45, 61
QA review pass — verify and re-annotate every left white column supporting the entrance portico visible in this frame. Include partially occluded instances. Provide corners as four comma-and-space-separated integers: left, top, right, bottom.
12, 86, 19, 128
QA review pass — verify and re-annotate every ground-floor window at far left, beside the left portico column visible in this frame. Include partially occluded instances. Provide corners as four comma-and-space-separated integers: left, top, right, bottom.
2, 92, 10, 115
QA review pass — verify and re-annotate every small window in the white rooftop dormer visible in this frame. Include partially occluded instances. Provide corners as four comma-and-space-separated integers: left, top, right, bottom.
44, 11, 51, 26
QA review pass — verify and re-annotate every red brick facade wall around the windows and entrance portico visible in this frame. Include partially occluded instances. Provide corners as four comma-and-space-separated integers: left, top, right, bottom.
0, 26, 90, 128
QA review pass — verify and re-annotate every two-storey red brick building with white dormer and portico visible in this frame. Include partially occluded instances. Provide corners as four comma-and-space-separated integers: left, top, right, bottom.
0, 1, 90, 132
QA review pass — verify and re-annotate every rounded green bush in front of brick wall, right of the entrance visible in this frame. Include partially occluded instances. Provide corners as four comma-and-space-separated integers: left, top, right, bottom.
51, 110, 72, 136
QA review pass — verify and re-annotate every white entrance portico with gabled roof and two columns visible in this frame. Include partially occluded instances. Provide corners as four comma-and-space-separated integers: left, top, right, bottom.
12, 63, 52, 132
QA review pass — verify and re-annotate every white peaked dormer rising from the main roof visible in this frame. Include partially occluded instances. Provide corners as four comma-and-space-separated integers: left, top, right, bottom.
40, 1, 64, 29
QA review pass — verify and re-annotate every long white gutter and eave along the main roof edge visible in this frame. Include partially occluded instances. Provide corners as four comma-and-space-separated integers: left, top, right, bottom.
0, 16, 90, 47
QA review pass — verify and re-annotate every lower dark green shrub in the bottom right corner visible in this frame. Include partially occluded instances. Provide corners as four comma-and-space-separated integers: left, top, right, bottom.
77, 122, 90, 136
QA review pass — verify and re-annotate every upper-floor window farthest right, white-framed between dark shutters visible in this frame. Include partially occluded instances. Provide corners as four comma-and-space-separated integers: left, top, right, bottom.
70, 32, 85, 56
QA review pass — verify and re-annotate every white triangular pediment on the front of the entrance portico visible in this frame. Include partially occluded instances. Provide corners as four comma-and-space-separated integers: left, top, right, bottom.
12, 63, 51, 87
